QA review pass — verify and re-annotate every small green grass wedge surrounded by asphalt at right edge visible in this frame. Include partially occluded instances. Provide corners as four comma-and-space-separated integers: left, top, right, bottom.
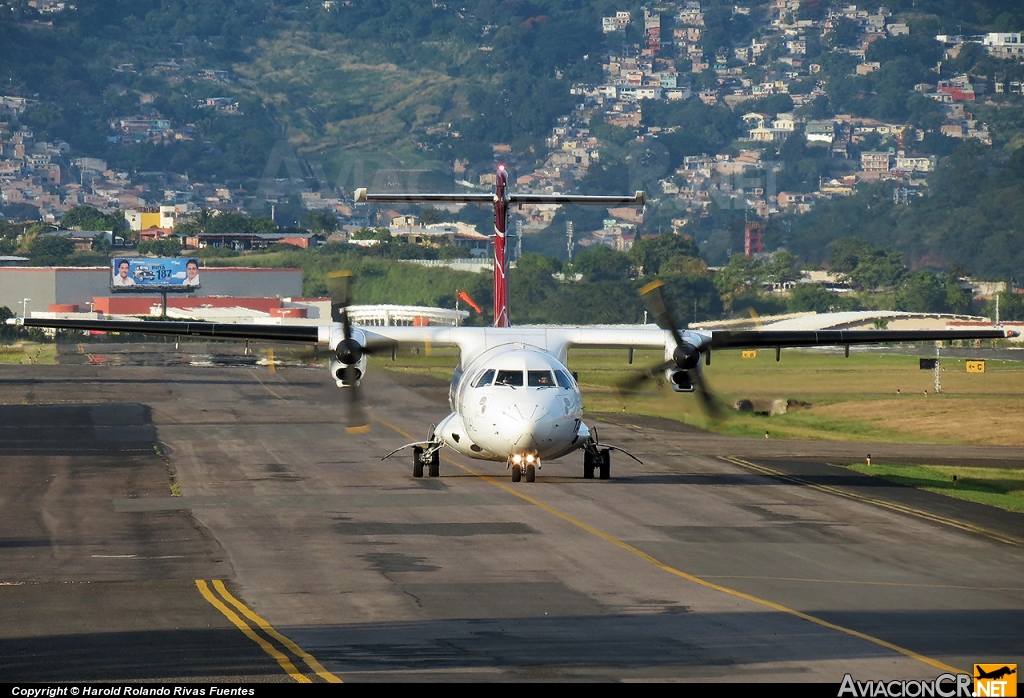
848, 464, 1024, 513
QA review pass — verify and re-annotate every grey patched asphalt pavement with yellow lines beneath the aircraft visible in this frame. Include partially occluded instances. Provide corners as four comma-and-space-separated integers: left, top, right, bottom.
0, 345, 1024, 685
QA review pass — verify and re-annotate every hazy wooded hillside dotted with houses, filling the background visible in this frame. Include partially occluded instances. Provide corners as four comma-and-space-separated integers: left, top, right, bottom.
0, 0, 1024, 296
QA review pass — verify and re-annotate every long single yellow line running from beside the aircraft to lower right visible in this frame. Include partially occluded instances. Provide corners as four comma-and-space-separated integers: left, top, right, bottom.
374, 416, 966, 673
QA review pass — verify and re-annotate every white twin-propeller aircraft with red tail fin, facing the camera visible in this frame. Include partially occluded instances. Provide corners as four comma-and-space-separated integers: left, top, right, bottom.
8, 167, 1017, 482
